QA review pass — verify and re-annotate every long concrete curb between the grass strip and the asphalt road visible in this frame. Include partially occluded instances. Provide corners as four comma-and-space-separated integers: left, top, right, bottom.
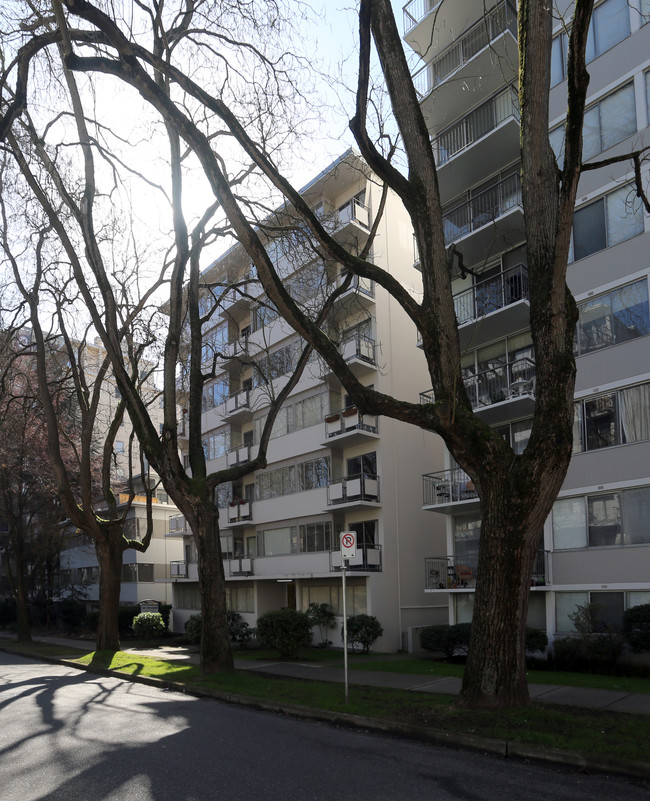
5, 643, 650, 780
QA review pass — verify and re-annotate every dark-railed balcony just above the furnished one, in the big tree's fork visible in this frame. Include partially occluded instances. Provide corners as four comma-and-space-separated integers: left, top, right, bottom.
454, 264, 530, 351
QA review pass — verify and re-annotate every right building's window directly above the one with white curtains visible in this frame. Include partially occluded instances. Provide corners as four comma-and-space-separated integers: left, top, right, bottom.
575, 278, 650, 356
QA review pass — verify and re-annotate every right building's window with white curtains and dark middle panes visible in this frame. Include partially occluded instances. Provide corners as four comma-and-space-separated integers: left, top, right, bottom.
573, 383, 650, 453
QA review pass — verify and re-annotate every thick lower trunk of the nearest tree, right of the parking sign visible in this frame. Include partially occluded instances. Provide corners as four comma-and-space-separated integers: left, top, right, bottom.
460, 487, 543, 708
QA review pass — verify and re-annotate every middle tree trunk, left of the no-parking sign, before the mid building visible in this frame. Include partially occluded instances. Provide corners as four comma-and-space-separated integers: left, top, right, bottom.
194, 504, 234, 673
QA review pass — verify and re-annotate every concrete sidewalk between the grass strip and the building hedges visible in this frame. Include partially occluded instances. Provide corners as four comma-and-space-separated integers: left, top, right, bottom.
5, 632, 650, 715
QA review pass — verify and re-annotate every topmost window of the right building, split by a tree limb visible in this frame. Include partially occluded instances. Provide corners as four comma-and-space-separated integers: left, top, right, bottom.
551, 0, 632, 86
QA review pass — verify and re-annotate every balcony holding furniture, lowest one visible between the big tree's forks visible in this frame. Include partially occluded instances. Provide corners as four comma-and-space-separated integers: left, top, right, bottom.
420, 357, 535, 425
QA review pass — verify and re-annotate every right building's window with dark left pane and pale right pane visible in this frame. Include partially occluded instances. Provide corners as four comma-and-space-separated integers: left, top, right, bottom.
573, 184, 643, 261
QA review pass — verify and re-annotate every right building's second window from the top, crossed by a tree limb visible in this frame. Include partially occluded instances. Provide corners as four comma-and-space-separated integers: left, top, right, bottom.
549, 81, 637, 163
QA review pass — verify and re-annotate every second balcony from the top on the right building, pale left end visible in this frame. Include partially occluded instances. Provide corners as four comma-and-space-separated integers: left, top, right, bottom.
413, 2, 518, 131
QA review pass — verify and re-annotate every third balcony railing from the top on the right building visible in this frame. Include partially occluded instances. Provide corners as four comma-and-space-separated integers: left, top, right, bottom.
431, 86, 519, 167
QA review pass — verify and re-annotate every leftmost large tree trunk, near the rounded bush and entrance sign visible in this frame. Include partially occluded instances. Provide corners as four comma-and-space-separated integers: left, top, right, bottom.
95, 527, 124, 651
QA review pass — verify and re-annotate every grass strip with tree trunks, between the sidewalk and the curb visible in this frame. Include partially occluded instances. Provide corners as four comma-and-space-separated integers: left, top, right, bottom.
64, 651, 650, 761
